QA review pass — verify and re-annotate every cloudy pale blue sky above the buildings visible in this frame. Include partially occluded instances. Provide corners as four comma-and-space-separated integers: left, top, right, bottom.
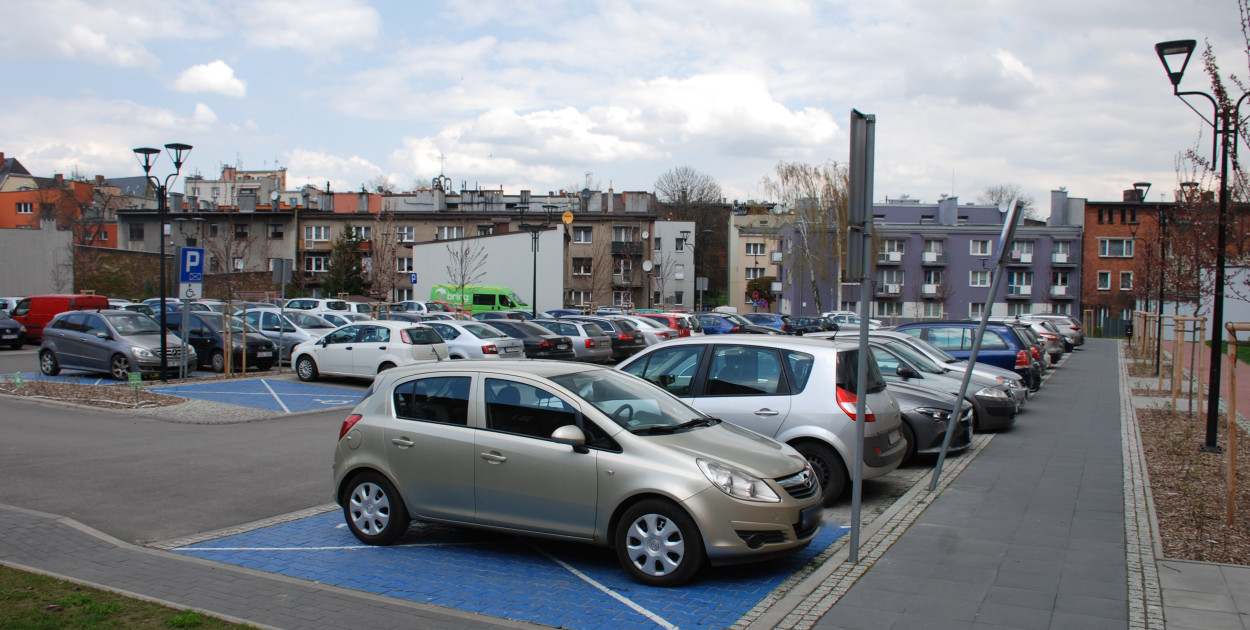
0, 0, 1250, 210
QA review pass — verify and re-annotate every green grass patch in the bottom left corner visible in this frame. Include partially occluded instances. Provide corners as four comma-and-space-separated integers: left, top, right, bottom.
0, 566, 251, 630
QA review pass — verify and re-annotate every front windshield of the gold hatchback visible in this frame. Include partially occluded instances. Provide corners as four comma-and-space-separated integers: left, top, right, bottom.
551, 370, 716, 434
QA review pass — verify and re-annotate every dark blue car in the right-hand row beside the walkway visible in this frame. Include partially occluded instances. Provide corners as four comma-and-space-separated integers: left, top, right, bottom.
894, 321, 1041, 391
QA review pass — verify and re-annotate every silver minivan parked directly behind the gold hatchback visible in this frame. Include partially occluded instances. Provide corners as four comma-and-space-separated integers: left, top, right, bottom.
618, 335, 906, 505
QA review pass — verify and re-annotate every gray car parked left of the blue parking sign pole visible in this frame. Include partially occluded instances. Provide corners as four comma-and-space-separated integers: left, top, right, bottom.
39, 310, 198, 380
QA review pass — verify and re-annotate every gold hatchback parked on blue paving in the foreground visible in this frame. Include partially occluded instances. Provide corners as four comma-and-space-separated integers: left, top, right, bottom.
334, 360, 821, 586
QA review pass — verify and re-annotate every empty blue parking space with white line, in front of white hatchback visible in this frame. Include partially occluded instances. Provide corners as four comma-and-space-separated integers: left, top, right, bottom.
149, 379, 363, 414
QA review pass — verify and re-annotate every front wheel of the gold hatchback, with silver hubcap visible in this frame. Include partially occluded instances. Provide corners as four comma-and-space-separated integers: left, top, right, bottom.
615, 499, 706, 586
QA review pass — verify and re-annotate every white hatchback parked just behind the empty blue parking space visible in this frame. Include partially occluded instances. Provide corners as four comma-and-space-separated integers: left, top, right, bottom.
291, 321, 448, 381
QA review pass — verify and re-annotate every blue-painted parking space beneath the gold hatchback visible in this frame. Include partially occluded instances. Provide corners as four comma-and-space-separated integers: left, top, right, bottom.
174, 510, 848, 630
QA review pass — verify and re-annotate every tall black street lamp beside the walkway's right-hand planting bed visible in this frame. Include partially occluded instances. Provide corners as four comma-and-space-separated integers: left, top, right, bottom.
1155, 40, 1250, 453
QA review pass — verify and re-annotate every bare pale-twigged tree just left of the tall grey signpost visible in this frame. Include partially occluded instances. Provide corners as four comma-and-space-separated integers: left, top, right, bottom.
764, 161, 850, 313
